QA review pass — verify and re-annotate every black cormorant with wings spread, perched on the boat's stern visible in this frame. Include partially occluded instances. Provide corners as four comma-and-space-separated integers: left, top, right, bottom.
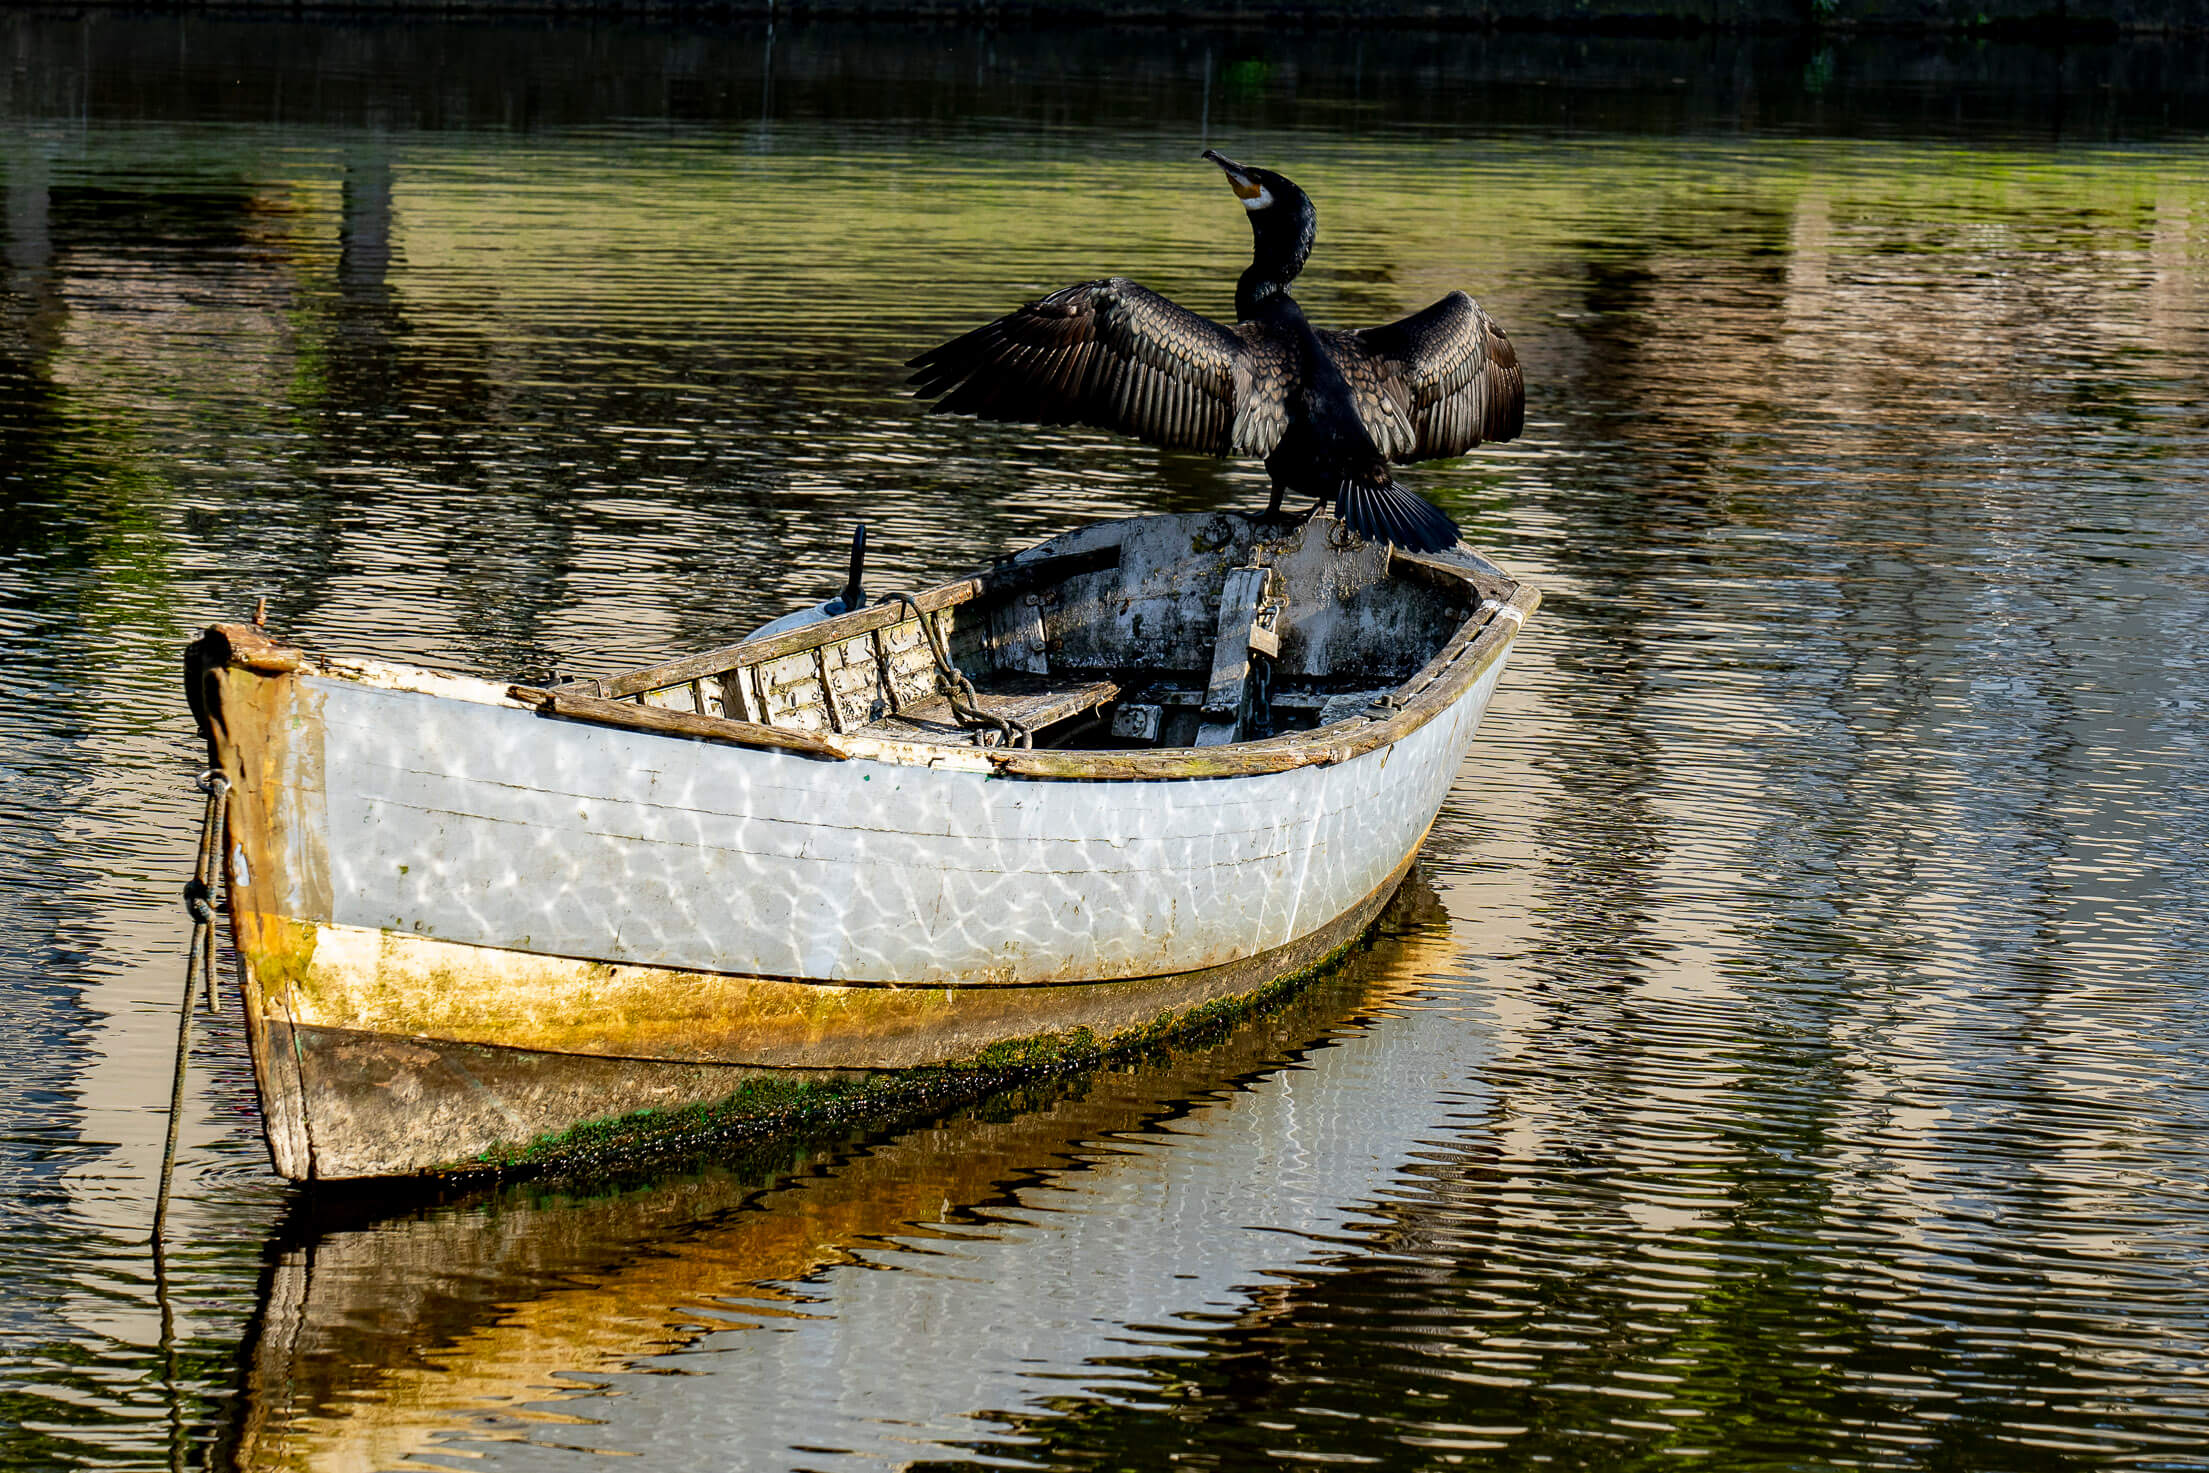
906, 148, 1526, 552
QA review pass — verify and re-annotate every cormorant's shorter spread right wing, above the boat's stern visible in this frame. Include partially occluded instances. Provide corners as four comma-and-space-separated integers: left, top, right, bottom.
1328, 292, 1526, 462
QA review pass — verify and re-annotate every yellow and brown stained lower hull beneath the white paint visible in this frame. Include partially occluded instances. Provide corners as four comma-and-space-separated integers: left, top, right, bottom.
239, 848, 1416, 1179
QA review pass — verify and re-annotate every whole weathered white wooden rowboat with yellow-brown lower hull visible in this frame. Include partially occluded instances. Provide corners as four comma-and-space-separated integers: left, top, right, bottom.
186, 515, 1540, 1179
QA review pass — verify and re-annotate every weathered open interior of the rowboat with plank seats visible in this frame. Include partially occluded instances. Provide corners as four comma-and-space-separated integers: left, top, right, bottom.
552, 512, 1515, 751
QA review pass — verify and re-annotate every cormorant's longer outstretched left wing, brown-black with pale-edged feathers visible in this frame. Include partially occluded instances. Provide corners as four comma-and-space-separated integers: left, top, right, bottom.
906, 276, 1292, 455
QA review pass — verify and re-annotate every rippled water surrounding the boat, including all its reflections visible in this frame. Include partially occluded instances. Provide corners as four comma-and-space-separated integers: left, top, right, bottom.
0, 15, 2209, 1469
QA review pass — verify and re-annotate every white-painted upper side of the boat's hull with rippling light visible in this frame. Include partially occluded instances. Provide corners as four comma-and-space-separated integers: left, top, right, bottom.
311, 660, 1502, 987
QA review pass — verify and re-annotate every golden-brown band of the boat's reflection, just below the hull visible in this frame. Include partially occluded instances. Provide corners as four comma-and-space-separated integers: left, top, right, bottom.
214, 868, 1451, 1469
